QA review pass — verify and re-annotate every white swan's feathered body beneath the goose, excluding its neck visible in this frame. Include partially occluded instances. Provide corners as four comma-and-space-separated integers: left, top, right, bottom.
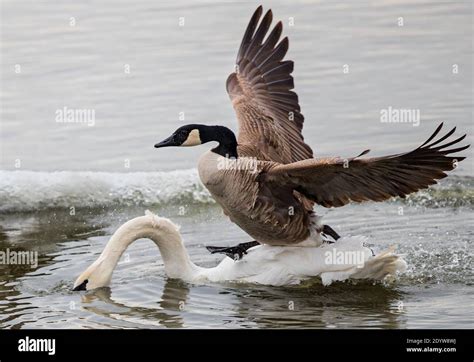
206, 236, 406, 286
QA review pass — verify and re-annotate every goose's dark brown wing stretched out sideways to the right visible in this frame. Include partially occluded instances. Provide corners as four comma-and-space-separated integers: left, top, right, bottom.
261, 123, 469, 207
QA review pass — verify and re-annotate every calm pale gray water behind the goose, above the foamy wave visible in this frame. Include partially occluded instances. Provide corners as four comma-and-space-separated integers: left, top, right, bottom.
1, 0, 474, 175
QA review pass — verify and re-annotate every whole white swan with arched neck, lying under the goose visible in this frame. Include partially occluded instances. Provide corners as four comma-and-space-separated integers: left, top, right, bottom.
74, 211, 406, 290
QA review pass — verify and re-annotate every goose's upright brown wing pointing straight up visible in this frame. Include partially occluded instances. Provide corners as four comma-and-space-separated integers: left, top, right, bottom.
226, 6, 313, 163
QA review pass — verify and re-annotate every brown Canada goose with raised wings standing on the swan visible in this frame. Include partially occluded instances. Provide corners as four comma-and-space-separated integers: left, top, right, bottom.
155, 6, 469, 256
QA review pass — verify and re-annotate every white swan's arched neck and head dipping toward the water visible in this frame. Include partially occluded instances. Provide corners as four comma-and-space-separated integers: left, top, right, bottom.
73, 211, 192, 291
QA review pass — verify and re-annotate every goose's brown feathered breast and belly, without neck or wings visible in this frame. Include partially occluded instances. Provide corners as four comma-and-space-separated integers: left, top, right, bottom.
198, 151, 312, 245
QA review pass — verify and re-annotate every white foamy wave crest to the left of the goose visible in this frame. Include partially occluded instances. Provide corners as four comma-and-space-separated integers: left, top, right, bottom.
0, 169, 214, 212
